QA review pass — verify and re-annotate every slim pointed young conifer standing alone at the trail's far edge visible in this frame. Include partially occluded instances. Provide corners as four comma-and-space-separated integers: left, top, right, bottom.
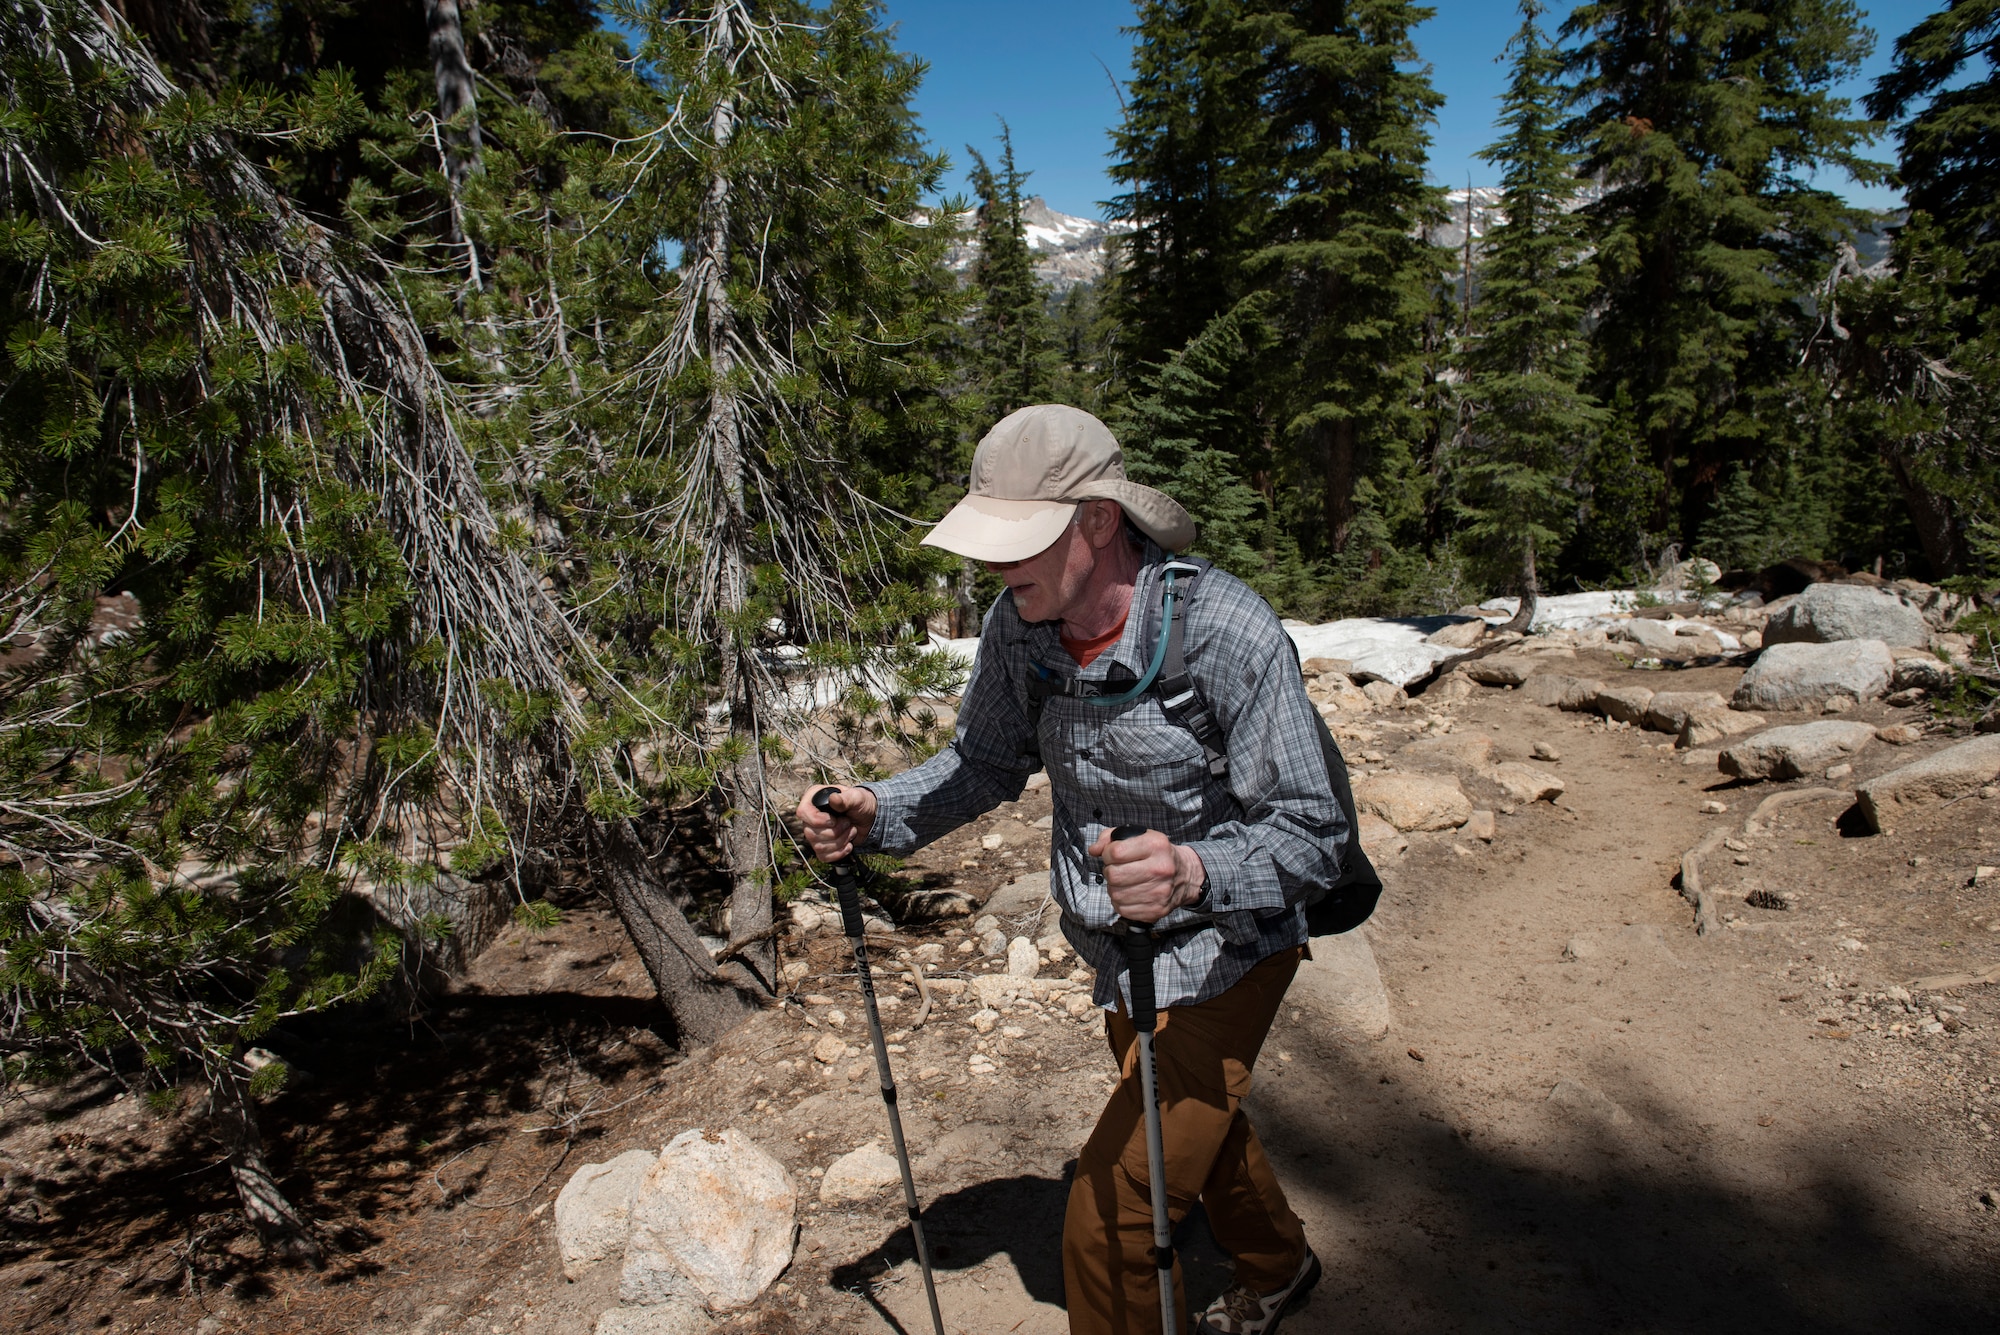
1454, 0, 1604, 630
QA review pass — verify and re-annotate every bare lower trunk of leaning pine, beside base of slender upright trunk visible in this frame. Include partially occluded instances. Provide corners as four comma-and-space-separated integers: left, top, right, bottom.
586, 819, 762, 1043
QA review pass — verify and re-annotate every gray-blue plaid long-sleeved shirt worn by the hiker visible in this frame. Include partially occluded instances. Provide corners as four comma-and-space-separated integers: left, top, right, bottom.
866, 544, 1350, 1005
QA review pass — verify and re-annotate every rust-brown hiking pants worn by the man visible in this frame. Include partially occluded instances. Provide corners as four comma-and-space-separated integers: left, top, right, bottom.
1062, 949, 1306, 1335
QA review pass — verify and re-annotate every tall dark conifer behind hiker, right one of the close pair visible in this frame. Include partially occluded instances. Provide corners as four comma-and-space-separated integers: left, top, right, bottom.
1250, 0, 1448, 554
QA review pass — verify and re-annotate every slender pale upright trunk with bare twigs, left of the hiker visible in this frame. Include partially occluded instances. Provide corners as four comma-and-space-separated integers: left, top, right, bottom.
702, 62, 778, 993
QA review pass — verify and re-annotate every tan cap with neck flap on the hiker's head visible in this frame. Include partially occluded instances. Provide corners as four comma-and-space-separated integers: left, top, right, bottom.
924, 404, 1194, 562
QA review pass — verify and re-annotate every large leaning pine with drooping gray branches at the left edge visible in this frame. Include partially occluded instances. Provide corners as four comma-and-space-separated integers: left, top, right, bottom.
0, 0, 610, 1259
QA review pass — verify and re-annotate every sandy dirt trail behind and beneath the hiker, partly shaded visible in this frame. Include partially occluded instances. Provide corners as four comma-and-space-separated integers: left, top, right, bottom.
862, 668, 2000, 1335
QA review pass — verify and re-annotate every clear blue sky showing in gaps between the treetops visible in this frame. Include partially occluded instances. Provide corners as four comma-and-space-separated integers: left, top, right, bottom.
886, 0, 1942, 216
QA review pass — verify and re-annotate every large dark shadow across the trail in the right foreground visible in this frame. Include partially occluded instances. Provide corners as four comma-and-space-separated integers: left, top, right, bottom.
834, 1053, 2000, 1335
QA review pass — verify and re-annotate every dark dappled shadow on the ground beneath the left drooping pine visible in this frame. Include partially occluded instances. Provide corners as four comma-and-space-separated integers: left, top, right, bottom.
0, 993, 672, 1331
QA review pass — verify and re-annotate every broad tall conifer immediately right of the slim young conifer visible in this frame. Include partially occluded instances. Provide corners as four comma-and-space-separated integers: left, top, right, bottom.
1562, 0, 1882, 559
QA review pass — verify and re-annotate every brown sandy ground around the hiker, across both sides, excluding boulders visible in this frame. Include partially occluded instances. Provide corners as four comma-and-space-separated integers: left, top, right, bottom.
0, 656, 2000, 1335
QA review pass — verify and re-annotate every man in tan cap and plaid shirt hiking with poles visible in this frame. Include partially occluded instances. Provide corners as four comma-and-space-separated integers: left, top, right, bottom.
798, 404, 1372, 1335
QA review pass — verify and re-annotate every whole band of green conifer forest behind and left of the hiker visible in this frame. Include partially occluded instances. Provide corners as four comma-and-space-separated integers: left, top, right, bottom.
0, 0, 2000, 1263
